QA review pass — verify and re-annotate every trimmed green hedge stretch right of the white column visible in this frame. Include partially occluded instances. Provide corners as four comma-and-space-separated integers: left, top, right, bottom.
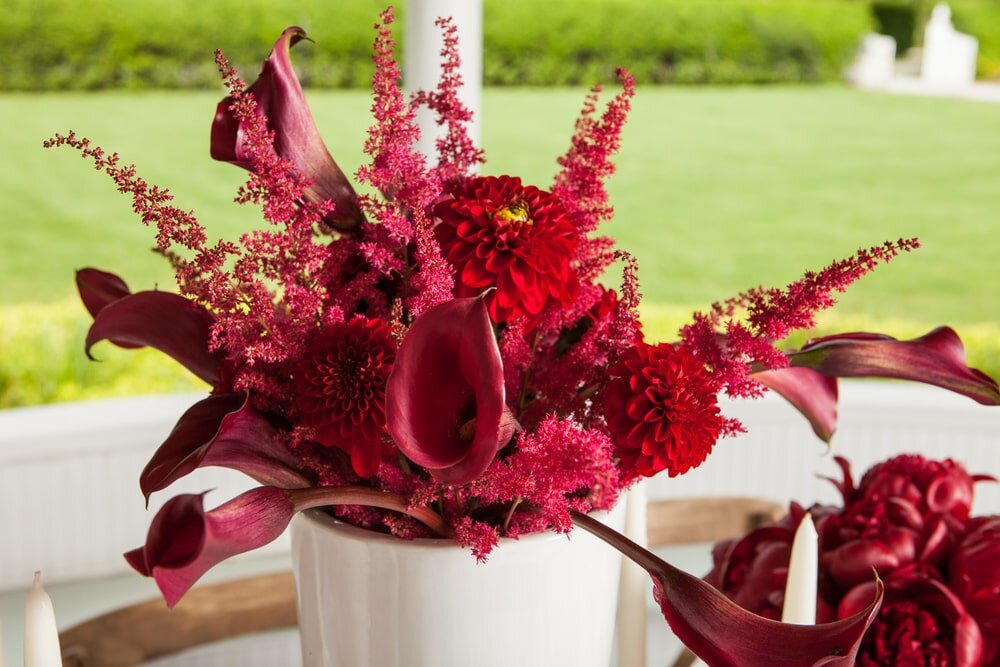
484, 0, 872, 85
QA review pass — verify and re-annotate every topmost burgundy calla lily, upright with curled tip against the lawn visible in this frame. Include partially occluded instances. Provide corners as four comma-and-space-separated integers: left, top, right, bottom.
211, 27, 362, 230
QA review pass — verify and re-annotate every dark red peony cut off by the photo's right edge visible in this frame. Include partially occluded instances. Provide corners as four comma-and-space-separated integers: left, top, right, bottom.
948, 516, 1000, 665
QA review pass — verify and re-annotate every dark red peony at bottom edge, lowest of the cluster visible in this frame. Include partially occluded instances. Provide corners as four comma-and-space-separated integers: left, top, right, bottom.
837, 566, 984, 667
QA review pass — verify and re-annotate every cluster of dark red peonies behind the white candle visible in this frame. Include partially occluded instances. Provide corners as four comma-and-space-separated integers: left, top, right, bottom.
706, 455, 1000, 667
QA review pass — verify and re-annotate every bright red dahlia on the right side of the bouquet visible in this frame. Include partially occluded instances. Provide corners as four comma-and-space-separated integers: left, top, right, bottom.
603, 341, 725, 479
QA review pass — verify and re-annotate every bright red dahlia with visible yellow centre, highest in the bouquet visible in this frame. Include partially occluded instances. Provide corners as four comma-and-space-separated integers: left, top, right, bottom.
434, 176, 580, 323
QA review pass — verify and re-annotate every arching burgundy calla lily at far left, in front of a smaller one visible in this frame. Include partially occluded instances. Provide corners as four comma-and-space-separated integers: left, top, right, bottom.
85, 292, 222, 384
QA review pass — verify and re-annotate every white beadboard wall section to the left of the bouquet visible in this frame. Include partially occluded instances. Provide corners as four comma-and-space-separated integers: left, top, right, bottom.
0, 394, 289, 591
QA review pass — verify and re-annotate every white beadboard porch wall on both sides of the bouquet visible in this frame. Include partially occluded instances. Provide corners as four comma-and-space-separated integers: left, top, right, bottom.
0, 382, 1000, 591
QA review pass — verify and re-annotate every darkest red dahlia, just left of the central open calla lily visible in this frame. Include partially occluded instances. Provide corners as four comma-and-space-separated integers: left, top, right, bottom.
295, 316, 396, 477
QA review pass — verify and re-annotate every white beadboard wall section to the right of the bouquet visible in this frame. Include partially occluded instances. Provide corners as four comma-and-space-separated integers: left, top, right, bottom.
647, 381, 1000, 514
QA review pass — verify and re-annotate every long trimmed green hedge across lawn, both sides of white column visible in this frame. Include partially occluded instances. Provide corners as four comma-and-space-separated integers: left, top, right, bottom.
0, 0, 873, 91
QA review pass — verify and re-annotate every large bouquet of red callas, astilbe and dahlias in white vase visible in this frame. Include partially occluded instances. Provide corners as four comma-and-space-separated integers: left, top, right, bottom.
46, 11, 1000, 667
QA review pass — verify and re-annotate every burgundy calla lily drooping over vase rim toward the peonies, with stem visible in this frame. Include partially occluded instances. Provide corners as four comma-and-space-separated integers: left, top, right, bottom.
573, 512, 882, 667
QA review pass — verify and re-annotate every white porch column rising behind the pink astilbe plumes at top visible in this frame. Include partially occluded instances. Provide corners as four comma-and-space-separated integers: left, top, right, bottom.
403, 0, 483, 160
